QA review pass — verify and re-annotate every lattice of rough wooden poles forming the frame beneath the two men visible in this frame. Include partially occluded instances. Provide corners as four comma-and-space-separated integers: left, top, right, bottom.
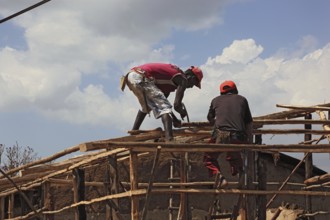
0, 103, 330, 220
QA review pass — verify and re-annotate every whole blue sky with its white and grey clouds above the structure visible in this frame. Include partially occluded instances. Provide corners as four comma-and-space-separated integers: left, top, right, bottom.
0, 0, 330, 172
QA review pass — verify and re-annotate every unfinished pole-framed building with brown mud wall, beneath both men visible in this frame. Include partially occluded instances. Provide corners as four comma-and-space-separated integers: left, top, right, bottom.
0, 103, 330, 220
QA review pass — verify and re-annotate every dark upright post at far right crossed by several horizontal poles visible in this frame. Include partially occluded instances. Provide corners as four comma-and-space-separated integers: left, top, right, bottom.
304, 114, 313, 217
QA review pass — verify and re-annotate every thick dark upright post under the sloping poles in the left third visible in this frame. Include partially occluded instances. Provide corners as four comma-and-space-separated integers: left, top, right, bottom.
72, 168, 87, 220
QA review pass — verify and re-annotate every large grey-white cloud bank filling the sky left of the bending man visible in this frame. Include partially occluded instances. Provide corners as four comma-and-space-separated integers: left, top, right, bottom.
0, 0, 227, 125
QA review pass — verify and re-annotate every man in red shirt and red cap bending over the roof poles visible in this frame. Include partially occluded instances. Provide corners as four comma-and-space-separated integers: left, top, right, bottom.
122, 63, 203, 141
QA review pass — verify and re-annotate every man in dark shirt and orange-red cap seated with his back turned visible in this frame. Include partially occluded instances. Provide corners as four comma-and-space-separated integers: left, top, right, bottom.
204, 81, 253, 188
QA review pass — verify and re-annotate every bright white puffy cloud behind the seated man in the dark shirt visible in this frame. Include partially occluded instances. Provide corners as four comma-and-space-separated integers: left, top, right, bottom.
180, 39, 330, 120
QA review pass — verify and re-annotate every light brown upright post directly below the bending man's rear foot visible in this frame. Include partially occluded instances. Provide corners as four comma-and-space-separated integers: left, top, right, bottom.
129, 150, 139, 220
